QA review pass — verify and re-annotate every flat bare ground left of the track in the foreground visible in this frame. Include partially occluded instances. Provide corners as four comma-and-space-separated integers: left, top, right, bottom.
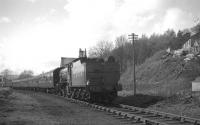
0, 91, 132, 125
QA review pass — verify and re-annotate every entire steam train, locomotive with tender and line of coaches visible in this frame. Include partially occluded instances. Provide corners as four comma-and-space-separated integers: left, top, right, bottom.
8, 51, 121, 102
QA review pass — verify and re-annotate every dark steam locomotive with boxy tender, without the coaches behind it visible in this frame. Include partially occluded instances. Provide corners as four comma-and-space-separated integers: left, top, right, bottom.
57, 57, 120, 102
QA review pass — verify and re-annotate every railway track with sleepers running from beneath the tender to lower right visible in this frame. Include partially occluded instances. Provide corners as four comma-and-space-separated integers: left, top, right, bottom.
55, 94, 200, 125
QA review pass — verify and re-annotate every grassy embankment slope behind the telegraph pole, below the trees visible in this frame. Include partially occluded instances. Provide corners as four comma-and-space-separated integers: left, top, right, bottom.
120, 51, 200, 96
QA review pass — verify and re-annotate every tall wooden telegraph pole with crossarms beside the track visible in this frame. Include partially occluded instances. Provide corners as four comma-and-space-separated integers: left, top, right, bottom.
128, 33, 138, 95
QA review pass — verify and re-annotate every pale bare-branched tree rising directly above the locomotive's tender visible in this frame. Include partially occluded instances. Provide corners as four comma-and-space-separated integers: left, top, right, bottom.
89, 41, 113, 58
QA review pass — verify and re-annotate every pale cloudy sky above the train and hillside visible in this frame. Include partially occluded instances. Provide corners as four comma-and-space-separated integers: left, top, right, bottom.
0, 0, 200, 74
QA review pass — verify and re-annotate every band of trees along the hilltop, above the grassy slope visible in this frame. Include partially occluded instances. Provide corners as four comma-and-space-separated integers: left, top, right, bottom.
89, 29, 190, 72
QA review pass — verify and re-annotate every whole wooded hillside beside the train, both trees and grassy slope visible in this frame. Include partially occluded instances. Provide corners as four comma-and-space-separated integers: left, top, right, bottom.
89, 24, 200, 96
